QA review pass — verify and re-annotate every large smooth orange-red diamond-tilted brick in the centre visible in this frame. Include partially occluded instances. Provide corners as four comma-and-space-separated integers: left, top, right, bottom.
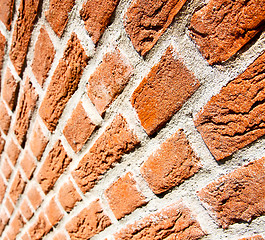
131, 46, 200, 135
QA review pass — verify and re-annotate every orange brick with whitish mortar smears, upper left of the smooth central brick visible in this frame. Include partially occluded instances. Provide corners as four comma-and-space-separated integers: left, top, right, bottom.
87, 49, 132, 116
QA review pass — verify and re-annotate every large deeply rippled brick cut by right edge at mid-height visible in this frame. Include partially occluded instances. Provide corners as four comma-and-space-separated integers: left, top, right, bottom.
194, 53, 265, 161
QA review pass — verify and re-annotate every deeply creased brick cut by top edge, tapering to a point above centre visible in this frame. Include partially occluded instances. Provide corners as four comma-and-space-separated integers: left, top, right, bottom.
125, 0, 186, 55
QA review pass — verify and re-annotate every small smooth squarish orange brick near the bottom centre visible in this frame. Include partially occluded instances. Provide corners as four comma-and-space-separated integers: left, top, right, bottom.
105, 173, 147, 219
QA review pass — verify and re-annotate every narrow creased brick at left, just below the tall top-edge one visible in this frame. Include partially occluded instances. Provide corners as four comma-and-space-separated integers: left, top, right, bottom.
13, 78, 38, 146
